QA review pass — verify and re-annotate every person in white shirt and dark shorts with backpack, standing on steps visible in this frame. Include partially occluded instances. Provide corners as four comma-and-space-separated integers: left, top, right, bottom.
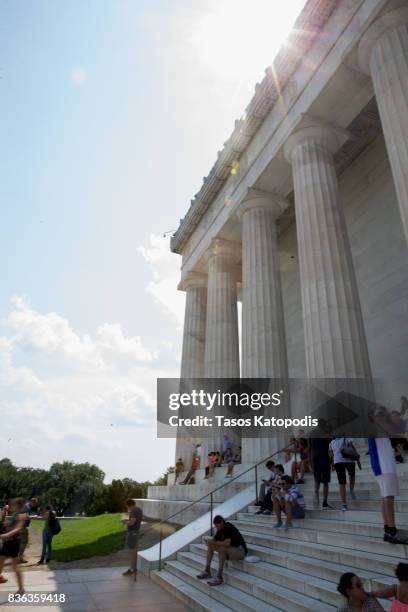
329, 436, 360, 512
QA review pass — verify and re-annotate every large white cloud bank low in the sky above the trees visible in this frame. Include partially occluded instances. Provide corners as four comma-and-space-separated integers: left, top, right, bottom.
0, 297, 177, 478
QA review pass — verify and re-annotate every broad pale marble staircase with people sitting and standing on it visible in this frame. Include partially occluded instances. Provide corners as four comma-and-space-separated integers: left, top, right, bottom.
151, 442, 408, 612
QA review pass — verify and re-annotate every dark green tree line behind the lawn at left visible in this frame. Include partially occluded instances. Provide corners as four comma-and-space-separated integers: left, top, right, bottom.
0, 457, 164, 516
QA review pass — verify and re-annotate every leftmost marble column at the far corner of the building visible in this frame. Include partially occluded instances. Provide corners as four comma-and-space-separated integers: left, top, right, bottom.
176, 272, 207, 469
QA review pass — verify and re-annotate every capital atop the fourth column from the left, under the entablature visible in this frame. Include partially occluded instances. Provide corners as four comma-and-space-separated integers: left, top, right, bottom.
283, 114, 350, 163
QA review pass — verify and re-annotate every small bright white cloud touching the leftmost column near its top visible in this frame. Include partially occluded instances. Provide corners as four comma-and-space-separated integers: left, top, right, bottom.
138, 234, 185, 327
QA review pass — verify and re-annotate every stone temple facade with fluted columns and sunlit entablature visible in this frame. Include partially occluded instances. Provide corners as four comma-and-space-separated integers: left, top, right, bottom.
172, 0, 408, 462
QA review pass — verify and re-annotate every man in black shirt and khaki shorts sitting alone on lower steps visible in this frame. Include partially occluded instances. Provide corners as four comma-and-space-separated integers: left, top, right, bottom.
197, 515, 248, 586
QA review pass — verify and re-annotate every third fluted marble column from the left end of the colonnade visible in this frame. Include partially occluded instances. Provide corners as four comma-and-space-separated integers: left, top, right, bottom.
238, 189, 288, 463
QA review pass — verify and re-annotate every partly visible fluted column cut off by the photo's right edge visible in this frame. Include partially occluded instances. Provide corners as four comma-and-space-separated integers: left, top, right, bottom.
359, 6, 408, 242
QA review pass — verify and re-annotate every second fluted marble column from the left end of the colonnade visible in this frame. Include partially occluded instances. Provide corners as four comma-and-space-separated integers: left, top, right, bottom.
202, 238, 241, 461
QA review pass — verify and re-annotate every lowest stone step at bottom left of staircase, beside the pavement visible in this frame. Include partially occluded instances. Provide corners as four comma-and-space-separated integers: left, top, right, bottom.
150, 570, 232, 612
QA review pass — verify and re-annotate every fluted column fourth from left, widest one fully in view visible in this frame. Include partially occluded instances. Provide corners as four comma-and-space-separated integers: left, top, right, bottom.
285, 125, 371, 380
